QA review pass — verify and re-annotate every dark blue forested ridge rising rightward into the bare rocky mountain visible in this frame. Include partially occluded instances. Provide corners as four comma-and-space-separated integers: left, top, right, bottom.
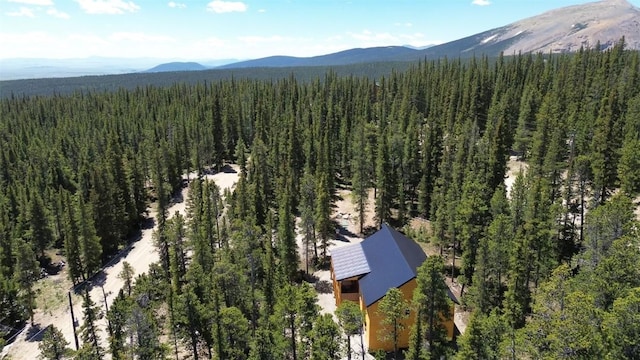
220, 0, 640, 69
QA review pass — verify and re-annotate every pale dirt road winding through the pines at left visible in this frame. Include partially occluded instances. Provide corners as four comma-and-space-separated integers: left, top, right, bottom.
0, 165, 239, 360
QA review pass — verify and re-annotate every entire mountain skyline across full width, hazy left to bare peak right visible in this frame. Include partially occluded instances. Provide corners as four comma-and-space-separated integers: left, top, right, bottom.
0, 0, 640, 80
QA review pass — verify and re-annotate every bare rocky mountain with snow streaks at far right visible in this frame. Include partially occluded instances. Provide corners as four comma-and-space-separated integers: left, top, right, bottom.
416, 0, 640, 57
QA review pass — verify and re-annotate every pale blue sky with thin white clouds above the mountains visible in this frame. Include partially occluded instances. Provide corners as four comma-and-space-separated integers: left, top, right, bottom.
0, 0, 640, 60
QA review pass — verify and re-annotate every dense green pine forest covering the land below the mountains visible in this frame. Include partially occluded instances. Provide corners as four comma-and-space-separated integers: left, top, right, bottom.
0, 41, 640, 360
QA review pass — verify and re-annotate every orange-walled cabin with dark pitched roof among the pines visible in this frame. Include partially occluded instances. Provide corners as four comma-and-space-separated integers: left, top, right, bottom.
331, 224, 457, 351
